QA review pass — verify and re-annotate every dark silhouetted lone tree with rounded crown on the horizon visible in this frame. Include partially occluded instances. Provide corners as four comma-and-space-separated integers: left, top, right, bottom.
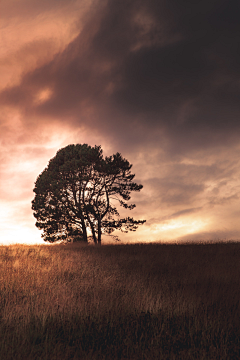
32, 144, 145, 244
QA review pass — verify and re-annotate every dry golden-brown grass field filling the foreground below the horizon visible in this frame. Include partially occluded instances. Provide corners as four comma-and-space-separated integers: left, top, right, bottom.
0, 243, 240, 360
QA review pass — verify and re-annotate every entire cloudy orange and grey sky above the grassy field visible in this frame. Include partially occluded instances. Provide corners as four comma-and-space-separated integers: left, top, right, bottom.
0, 0, 240, 244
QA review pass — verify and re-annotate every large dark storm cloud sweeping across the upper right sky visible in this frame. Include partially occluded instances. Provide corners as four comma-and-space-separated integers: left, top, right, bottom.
1, 0, 240, 154
